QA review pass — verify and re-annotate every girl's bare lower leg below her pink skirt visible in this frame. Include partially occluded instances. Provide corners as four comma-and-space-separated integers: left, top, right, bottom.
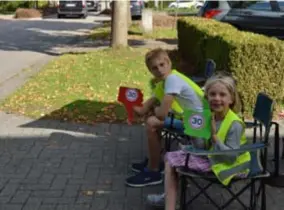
165, 162, 178, 210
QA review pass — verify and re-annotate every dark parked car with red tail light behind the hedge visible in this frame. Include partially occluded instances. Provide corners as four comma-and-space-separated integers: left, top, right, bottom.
198, 0, 284, 38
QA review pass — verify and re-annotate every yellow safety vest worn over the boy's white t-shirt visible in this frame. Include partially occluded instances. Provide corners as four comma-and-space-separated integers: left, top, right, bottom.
154, 70, 204, 114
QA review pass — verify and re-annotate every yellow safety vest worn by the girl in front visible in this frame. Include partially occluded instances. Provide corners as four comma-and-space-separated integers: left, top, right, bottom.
209, 110, 251, 185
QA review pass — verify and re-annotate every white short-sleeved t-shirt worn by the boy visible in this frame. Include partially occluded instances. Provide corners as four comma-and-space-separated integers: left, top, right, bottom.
164, 74, 203, 111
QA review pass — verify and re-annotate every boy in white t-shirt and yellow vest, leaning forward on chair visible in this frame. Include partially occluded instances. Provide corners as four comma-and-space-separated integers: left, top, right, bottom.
126, 48, 203, 187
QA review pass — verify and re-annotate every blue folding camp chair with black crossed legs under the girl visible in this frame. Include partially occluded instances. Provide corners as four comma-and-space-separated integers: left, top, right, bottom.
177, 93, 279, 210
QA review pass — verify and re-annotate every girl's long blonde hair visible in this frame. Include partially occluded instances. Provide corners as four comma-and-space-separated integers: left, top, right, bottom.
204, 73, 242, 113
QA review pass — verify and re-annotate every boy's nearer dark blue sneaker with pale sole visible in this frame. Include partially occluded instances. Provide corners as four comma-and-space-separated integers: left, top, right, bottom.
126, 168, 163, 187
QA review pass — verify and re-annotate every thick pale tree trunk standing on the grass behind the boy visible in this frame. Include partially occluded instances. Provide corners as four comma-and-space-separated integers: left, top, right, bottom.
111, 0, 128, 47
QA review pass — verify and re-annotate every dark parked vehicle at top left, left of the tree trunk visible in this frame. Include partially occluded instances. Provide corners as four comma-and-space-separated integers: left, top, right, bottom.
57, 0, 88, 18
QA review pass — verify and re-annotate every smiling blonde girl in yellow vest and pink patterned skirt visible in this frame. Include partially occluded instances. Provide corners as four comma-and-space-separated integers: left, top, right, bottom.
147, 75, 250, 210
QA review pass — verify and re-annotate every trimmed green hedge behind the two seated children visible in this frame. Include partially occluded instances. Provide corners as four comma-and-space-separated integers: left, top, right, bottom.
177, 17, 284, 114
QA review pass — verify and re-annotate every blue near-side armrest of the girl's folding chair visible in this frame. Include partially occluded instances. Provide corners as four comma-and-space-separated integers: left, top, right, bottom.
181, 143, 267, 156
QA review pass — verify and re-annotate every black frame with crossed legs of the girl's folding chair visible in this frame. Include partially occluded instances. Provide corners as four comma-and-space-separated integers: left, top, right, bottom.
177, 93, 280, 210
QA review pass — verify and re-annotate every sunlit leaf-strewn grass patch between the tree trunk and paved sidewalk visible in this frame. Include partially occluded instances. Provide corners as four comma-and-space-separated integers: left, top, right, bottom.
0, 48, 151, 124
